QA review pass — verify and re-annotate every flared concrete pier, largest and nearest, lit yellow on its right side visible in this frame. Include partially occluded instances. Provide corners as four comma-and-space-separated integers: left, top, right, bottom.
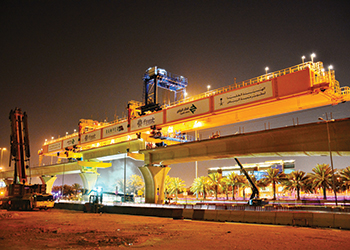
139, 166, 170, 204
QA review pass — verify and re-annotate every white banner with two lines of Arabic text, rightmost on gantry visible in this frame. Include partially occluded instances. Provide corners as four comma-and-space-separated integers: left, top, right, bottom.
214, 81, 273, 110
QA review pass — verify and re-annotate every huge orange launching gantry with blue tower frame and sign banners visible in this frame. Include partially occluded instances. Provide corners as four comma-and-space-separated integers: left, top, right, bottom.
39, 59, 350, 163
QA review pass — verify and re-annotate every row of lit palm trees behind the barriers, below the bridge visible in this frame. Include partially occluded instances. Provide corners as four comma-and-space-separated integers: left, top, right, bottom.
165, 164, 350, 200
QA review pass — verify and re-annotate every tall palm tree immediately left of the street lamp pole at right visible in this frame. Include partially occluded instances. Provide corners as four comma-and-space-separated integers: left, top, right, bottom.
307, 164, 333, 200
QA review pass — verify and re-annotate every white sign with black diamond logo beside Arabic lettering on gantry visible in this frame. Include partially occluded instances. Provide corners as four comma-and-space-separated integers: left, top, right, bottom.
166, 98, 209, 122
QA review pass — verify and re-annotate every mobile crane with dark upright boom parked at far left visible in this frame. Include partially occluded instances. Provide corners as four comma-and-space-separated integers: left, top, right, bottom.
1, 108, 54, 210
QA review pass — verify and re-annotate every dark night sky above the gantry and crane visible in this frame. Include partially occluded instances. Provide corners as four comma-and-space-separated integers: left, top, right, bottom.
0, 0, 350, 184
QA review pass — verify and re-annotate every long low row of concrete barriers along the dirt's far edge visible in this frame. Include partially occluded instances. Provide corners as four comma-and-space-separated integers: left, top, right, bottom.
54, 203, 350, 229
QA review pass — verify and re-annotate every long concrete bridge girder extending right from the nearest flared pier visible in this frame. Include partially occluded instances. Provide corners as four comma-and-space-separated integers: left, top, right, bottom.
141, 118, 350, 165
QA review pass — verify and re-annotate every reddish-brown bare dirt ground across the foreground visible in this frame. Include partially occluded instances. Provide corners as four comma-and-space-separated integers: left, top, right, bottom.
0, 209, 350, 250
